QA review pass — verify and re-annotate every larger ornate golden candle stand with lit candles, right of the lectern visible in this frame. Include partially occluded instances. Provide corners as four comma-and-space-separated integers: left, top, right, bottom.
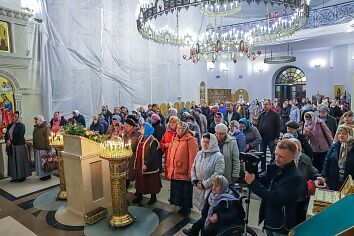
100, 139, 134, 229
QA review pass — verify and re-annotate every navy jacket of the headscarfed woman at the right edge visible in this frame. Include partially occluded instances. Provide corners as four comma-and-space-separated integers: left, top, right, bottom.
322, 141, 354, 190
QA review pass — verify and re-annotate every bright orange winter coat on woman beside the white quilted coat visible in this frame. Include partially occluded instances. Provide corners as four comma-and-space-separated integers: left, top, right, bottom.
165, 132, 199, 181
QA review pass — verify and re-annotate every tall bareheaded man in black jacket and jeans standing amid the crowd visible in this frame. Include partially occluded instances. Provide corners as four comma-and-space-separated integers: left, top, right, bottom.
258, 100, 280, 171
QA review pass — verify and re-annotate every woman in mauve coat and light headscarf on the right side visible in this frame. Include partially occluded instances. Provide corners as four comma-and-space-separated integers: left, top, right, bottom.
303, 111, 333, 172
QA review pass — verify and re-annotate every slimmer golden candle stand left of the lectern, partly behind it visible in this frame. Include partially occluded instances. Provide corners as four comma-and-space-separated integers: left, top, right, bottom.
49, 133, 68, 201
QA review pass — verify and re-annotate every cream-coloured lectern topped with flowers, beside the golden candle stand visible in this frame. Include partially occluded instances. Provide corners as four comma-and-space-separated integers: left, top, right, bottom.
63, 135, 111, 222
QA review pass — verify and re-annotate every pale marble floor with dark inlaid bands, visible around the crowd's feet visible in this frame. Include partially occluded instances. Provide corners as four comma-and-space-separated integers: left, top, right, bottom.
0, 173, 263, 236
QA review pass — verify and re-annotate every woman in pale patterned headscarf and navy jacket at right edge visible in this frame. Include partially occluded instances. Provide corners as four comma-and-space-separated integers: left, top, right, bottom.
322, 125, 354, 190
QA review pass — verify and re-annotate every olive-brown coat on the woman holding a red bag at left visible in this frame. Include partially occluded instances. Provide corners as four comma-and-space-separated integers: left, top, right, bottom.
33, 121, 51, 150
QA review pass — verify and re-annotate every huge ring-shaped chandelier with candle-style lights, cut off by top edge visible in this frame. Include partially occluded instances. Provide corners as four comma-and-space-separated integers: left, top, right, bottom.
137, 0, 309, 62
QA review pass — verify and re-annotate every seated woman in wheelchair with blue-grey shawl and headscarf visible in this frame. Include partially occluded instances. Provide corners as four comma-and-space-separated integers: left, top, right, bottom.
183, 175, 245, 236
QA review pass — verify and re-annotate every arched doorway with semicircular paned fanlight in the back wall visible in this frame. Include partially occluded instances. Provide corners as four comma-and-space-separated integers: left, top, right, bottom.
274, 66, 306, 102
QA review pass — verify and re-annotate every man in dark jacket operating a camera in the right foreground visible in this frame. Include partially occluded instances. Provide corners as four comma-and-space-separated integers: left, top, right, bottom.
245, 140, 307, 236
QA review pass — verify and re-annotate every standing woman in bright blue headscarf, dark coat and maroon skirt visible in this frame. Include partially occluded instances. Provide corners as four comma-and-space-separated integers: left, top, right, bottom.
133, 122, 162, 205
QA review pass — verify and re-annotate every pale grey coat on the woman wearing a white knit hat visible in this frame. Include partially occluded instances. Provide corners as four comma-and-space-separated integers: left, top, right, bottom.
219, 135, 240, 183
